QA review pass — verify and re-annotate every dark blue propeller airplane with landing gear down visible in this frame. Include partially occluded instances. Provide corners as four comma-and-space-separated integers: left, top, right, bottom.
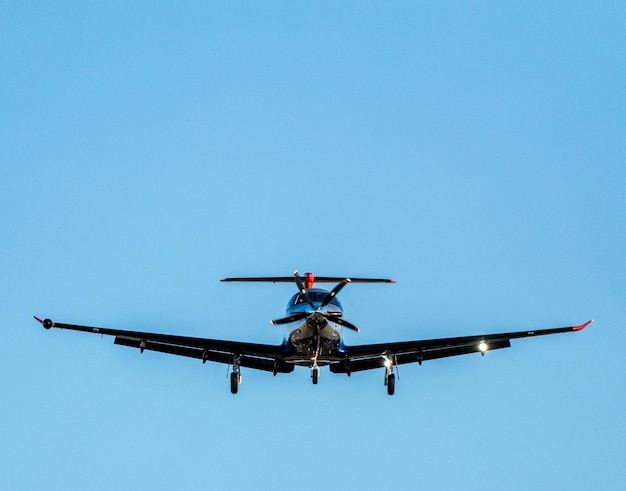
33, 271, 593, 395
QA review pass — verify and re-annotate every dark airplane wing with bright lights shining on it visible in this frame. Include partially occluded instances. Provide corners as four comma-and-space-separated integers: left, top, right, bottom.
330, 321, 593, 373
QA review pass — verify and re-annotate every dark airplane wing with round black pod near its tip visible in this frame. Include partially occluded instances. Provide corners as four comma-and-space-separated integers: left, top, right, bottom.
35, 317, 294, 373
